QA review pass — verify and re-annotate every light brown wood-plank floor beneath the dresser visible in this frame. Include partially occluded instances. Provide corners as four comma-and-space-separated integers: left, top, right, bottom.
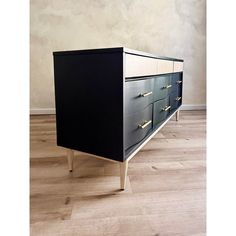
30, 111, 206, 236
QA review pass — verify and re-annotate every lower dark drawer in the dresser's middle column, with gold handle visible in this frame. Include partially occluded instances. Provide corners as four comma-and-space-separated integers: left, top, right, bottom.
153, 96, 171, 126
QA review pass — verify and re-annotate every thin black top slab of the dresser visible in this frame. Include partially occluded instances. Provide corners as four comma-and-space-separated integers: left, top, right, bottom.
53, 47, 184, 62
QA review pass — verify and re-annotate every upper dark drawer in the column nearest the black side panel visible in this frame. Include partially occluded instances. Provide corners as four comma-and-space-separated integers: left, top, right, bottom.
125, 78, 154, 114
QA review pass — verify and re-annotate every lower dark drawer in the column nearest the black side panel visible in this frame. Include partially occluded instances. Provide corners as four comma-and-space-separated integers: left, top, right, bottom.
125, 104, 152, 149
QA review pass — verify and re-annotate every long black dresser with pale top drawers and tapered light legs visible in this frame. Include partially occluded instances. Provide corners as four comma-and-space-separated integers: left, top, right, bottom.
53, 47, 183, 189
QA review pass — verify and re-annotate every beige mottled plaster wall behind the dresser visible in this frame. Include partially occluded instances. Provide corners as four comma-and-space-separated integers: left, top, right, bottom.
30, 0, 206, 109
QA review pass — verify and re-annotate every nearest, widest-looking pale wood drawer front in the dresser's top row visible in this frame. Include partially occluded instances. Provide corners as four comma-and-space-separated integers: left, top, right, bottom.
125, 53, 157, 77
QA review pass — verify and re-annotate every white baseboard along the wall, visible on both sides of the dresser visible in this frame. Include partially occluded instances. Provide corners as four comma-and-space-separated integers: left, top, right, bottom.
30, 104, 206, 115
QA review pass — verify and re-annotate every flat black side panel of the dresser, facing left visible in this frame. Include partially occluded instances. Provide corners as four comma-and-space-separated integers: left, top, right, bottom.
54, 52, 124, 161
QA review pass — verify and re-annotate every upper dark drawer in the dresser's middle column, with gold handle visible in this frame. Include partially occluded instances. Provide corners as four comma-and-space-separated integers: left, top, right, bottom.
153, 75, 172, 101
